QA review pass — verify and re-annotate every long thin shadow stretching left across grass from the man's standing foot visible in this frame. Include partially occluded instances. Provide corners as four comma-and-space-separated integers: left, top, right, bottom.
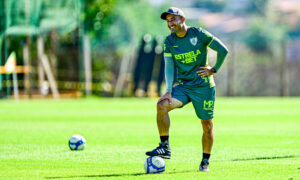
45, 170, 196, 179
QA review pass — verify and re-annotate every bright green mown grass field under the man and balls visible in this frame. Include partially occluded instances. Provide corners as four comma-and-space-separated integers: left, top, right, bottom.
0, 97, 300, 180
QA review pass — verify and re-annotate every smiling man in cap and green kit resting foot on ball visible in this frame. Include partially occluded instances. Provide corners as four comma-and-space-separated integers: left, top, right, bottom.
146, 7, 228, 171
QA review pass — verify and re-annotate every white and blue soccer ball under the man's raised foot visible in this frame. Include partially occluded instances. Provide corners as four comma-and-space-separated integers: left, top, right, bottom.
144, 156, 166, 173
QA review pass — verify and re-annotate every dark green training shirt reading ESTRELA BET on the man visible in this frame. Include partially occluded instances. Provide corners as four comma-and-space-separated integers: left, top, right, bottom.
164, 27, 215, 87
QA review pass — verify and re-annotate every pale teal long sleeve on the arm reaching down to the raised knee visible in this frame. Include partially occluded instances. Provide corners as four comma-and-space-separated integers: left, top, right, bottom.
164, 39, 174, 92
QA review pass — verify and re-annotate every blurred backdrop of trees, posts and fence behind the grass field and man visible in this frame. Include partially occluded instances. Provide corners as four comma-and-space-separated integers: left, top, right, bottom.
0, 0, 300, 99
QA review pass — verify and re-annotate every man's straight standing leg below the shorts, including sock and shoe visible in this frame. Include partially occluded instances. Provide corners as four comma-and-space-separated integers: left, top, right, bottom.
200, 119, 215, 171
